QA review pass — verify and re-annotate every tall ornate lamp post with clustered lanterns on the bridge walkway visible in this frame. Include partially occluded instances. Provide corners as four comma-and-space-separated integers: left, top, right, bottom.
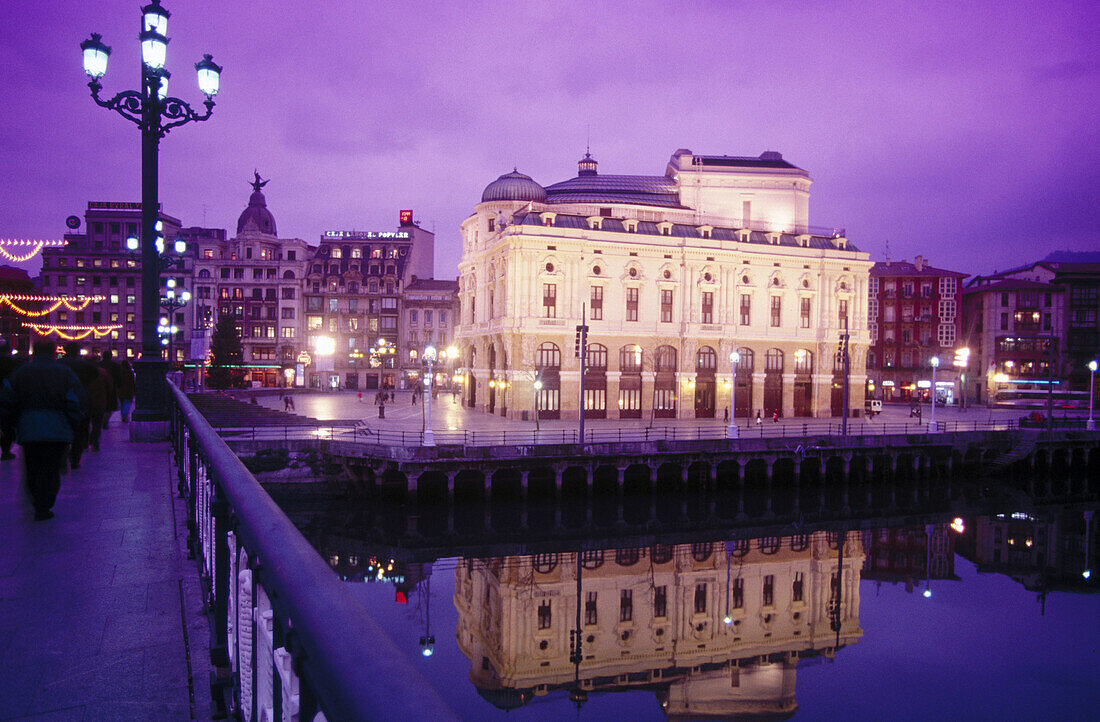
80, 0, 221, 437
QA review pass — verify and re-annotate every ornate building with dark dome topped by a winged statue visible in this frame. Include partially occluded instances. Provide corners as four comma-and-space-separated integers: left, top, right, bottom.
185, 174, 311, 386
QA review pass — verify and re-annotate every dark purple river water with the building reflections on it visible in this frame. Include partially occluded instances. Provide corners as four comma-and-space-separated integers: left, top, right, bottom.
288, 477, 1100, 720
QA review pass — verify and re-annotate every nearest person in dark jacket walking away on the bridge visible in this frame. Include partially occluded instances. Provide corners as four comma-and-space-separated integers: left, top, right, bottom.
0, 339, 85, 522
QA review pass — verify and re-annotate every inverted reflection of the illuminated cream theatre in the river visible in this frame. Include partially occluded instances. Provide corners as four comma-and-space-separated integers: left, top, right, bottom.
454, 533, 864, 718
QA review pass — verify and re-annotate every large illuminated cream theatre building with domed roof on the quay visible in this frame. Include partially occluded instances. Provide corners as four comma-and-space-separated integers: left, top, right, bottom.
455, 150, 871, 418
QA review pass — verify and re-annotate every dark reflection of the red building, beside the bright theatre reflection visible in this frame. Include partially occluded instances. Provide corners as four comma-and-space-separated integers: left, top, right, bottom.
862, 524, 958, 591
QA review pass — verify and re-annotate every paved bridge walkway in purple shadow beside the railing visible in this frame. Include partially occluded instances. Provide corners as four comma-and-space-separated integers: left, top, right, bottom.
0, 417, 211, 722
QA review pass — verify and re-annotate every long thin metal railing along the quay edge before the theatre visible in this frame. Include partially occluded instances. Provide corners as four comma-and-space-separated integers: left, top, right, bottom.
218, 418, 1020, 447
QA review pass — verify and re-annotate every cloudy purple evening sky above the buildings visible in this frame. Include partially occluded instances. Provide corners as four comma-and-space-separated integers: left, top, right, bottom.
0, 0, 1100, 277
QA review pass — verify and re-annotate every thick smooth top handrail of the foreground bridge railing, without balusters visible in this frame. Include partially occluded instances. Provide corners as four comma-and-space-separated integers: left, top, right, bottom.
168, 384, 457, 720
